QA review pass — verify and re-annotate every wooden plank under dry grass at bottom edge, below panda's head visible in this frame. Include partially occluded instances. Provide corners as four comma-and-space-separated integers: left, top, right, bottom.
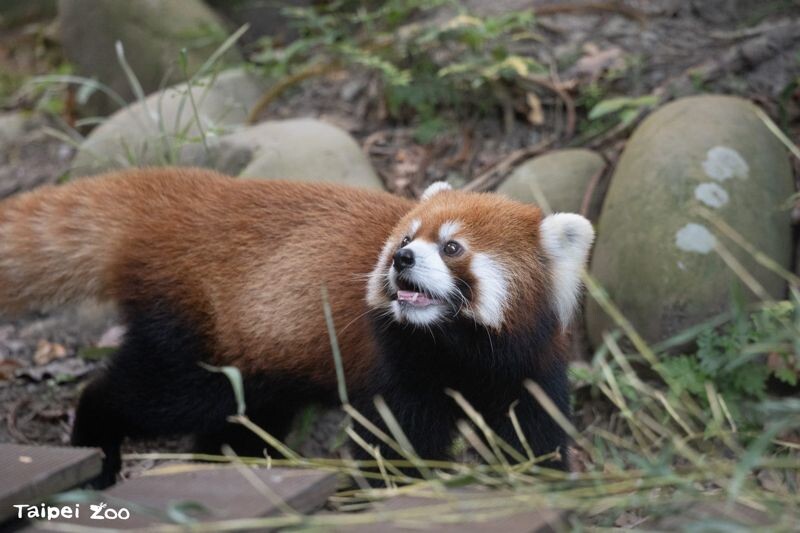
335, 490, 567, 533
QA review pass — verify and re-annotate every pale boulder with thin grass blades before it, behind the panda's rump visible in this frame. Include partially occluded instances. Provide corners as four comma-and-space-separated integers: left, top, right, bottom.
72, 69, 265, 176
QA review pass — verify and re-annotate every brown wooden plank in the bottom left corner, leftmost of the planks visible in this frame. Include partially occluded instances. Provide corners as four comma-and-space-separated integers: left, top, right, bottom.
0, 444, 103, 522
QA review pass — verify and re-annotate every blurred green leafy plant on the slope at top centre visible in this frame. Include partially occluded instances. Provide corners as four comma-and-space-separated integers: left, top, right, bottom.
251, 0, 544, 141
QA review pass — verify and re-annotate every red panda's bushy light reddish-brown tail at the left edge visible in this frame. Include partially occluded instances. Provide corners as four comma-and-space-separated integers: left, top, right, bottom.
0, 175, 134, 312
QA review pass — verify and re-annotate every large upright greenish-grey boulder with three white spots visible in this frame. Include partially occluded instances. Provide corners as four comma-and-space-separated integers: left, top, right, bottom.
587, 96, 794, 346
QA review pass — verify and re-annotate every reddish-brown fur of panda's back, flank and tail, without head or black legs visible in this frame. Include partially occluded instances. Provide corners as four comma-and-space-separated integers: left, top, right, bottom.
0, 168, 414, 386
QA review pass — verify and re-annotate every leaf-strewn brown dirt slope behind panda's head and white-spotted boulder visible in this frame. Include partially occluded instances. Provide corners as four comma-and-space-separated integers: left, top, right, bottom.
262, 0, 800, 196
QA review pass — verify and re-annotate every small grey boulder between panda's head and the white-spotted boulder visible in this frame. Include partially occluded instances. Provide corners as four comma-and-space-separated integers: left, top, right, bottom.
497, 148, 606, 218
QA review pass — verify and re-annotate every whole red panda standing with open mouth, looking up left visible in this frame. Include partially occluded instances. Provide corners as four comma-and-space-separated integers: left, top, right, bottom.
0, 168, 594, 482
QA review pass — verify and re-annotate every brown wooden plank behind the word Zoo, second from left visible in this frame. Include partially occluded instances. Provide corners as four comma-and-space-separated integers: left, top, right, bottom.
29, 463, 336, 531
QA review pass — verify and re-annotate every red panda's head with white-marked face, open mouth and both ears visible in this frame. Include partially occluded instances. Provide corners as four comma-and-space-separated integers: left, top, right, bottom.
367, 183, 594, 330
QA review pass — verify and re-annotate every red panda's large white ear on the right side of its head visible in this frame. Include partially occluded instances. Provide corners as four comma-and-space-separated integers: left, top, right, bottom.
540, 213, 594, 327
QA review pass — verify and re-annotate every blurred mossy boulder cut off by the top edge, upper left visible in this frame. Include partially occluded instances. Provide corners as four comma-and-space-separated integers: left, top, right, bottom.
58, 0, 241, 114
